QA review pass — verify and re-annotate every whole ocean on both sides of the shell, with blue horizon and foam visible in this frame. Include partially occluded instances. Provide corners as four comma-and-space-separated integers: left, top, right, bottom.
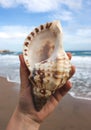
0, 51, 91, 100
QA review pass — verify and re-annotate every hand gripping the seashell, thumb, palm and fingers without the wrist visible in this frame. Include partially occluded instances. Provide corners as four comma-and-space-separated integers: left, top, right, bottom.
19, 53, 75, 123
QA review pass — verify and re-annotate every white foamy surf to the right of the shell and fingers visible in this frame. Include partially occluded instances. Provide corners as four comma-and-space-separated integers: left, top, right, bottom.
70, 56, 91, 100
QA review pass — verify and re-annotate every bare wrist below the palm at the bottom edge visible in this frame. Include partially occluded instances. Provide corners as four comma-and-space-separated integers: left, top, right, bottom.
6, 108, 40, 130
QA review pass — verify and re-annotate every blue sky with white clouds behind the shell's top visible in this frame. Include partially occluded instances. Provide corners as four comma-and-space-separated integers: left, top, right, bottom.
0, 0, 91, 51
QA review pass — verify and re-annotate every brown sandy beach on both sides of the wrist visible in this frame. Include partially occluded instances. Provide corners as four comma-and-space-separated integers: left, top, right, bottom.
0, 77, 91, 130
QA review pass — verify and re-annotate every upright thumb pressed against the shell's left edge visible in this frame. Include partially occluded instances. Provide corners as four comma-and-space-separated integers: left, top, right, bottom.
19, 54, 29, 88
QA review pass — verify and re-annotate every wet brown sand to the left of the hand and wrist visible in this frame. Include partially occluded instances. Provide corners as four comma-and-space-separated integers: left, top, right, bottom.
0, 77, 19, 130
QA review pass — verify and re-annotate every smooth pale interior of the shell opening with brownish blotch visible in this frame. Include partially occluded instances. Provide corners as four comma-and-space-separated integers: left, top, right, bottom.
23, 29, 56, 71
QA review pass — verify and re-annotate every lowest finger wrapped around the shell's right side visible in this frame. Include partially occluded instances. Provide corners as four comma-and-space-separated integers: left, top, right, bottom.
54, 81, 72, 102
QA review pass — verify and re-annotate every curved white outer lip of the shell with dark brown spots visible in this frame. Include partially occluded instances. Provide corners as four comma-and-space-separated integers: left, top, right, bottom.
23, 20, 59, 71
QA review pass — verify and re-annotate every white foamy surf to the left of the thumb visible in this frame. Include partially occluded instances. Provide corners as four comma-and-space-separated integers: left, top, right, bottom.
0, 55, 20, 82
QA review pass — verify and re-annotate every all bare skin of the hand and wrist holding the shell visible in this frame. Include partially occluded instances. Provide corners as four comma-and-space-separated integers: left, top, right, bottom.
6, 53, 75, 130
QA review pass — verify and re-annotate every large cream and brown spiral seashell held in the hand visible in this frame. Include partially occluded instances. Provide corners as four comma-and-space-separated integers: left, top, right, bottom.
23, 21, 71, 111
